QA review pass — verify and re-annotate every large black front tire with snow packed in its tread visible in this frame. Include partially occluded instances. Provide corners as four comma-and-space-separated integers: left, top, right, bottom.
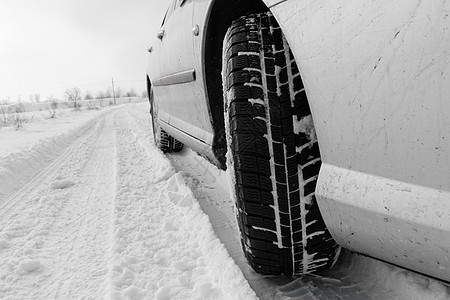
222, 12, 340, 275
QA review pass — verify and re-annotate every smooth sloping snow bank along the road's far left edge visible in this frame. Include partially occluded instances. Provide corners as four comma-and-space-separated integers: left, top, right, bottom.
0, 108, 112, 198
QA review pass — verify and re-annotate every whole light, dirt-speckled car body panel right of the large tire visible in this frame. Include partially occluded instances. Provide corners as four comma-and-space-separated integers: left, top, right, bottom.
272, 0, 450, 281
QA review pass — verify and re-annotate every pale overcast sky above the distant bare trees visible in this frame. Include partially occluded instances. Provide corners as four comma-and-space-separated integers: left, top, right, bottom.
0, 0, 168, 101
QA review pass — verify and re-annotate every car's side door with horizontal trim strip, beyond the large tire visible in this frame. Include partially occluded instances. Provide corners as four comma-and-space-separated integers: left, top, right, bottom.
152, 0, 212, 143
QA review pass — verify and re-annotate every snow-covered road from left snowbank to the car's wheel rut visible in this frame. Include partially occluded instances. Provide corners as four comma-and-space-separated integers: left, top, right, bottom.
0, 105, 256, 299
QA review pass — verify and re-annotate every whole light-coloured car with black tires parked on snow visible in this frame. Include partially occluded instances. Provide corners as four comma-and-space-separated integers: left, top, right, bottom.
146, 0, 450, 281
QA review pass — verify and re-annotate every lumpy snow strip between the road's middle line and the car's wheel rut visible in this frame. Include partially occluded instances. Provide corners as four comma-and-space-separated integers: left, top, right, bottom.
106, 105, 255, 300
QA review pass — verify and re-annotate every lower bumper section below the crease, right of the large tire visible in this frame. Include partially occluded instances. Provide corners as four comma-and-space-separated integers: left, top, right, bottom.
316, 164, 450, 281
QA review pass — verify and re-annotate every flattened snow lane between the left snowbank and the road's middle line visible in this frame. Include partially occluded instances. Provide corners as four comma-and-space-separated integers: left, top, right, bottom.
0, 113, 115, 299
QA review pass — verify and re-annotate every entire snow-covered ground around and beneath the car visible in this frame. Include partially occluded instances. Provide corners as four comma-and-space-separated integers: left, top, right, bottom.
0, 103, 450, 300
